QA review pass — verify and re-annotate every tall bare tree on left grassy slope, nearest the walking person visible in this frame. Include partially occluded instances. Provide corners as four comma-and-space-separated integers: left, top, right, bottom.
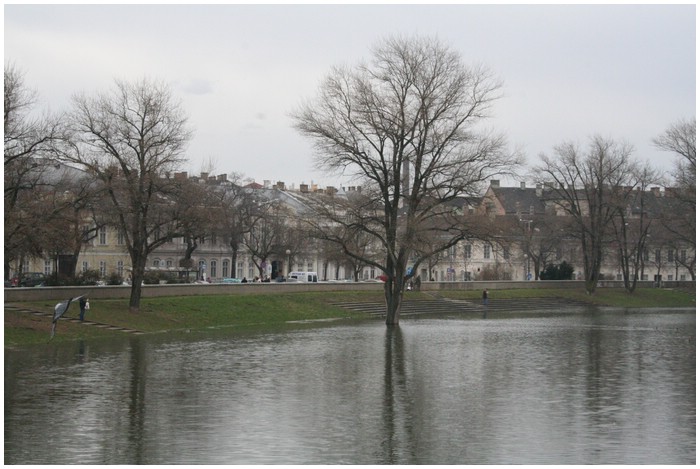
64, 79, 191, 312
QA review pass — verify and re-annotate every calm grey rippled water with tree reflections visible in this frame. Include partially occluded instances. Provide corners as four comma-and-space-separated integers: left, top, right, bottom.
4, 311, 696, 464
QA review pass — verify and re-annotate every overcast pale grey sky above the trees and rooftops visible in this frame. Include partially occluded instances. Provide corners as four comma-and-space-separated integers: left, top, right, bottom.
4, 4, 696, 186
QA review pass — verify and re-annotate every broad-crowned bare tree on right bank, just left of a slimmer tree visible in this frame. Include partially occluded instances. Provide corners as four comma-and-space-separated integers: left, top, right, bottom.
534, 136, 636, 294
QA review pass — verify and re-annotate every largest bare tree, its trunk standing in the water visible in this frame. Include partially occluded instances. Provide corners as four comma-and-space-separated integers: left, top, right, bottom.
293, 37, 517, 325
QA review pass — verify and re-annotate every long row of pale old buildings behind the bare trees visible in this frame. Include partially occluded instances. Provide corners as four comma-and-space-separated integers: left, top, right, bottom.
15, 173, 695, 282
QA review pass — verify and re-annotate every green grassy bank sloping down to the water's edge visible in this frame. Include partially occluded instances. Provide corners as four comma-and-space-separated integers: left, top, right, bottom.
4, 289, 695, 347
